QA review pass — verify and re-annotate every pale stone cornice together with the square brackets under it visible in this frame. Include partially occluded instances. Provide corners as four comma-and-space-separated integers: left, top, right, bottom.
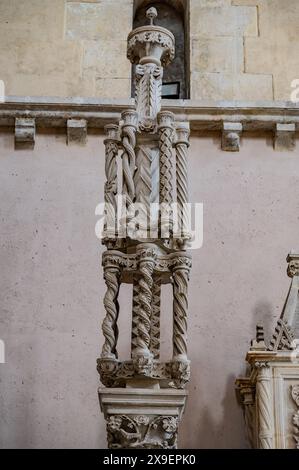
0, 96, 299, 152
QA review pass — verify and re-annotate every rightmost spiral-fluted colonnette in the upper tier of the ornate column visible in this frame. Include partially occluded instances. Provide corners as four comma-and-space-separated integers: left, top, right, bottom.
175, 123, 190, 237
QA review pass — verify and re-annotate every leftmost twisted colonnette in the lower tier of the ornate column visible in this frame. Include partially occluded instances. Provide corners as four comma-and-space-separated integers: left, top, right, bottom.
101, 258, 121, 359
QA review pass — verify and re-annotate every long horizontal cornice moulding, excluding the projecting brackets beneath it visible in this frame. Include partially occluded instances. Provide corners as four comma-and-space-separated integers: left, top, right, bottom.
0, 96, 299, 131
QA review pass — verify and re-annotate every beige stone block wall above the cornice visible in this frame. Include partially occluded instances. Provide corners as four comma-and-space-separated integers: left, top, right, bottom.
0, 0, 299, 101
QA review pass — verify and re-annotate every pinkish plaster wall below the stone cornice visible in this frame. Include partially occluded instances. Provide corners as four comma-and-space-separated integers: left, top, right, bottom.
0, 129, 299, 448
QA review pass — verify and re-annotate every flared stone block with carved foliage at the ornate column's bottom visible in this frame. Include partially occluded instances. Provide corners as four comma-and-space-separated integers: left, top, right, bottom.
98, 388, 188, 449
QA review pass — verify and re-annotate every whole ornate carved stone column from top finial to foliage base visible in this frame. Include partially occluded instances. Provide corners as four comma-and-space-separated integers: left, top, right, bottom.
97, 8, 191, 449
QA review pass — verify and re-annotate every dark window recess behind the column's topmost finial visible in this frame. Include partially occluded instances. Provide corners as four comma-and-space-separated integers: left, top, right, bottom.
132, 0, 189, 99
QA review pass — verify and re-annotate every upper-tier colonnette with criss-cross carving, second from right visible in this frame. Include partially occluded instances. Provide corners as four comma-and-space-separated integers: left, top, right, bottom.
158, 111, 174, 238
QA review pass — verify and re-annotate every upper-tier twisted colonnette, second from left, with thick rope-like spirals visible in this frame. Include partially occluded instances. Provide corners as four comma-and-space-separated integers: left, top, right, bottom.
121, 111, 138, 231
